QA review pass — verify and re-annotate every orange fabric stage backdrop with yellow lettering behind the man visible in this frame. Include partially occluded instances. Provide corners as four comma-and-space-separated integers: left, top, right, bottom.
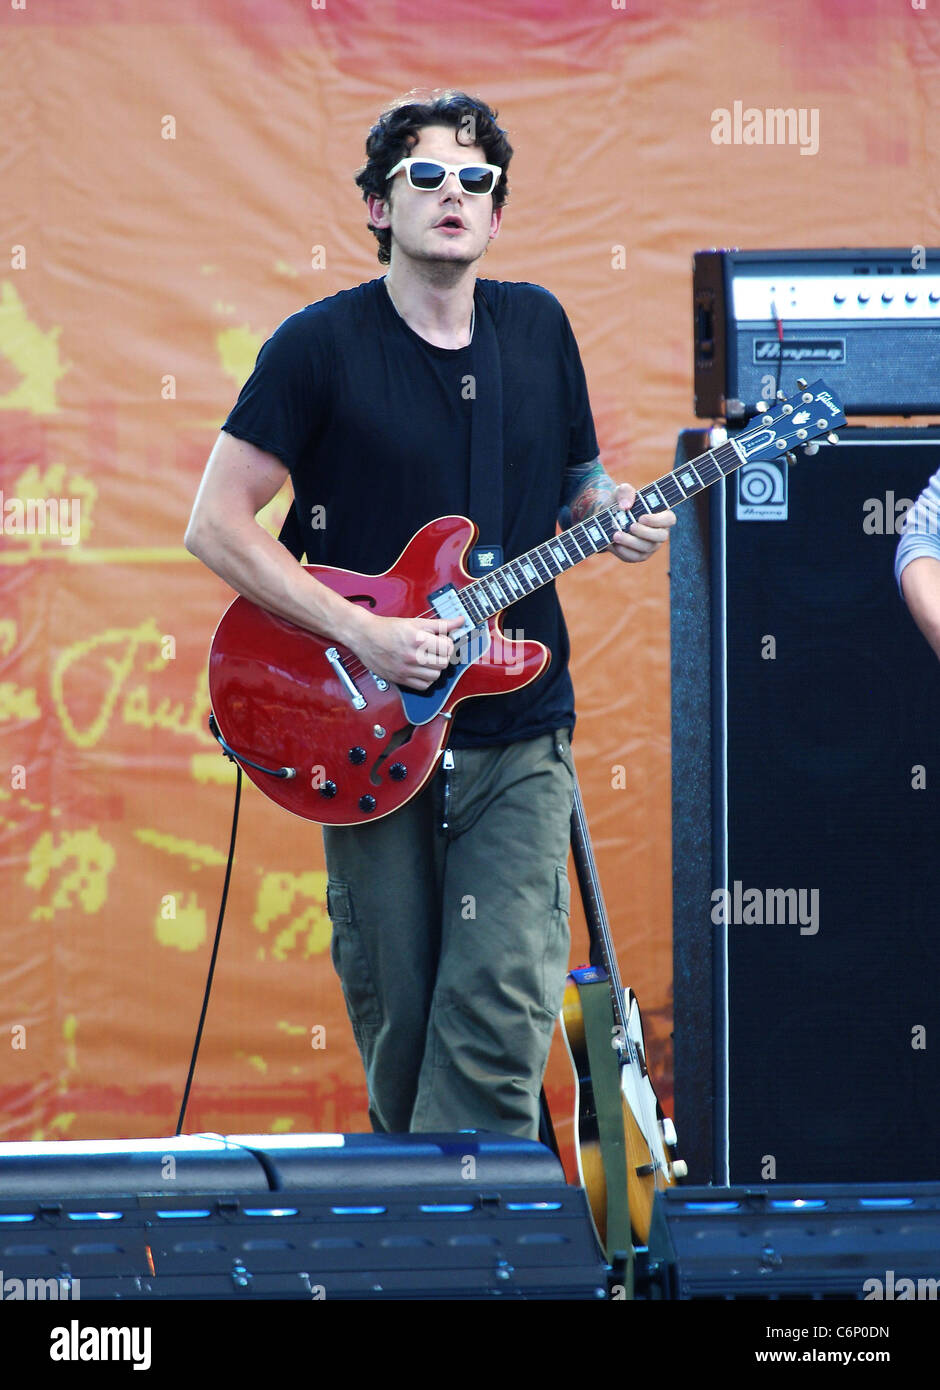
0, 0, 940, 1173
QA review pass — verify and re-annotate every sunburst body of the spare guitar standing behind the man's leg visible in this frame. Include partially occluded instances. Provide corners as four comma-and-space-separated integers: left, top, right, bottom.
562, 967, 686, 1248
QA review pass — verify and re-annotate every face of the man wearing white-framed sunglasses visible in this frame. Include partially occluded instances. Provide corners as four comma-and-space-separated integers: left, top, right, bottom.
368, 125, 502, 265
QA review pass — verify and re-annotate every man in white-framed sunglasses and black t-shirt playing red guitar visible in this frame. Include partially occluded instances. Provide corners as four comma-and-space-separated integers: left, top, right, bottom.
186, 92, 674, 1137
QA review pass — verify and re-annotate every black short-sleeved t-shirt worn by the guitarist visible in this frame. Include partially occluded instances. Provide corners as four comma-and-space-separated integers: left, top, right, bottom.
222, 278, 598, 748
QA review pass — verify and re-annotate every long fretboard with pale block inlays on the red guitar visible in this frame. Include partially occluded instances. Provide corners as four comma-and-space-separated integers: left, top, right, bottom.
460, 442, 744, 623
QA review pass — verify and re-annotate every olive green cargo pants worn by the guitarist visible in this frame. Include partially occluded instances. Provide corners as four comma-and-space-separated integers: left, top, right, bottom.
323, 730, 574, 1138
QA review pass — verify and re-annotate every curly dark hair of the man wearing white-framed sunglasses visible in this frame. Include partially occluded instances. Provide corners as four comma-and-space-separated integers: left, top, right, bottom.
356, 92, 513, 265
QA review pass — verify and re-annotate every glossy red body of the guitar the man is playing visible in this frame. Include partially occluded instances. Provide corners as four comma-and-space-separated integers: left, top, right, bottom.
209, 516, 549, 826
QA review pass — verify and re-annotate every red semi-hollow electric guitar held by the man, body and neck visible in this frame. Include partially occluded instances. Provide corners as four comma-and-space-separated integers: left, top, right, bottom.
209, 381, 845, 826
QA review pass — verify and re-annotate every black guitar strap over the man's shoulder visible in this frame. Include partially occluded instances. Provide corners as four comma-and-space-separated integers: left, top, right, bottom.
278, 282, 503, 578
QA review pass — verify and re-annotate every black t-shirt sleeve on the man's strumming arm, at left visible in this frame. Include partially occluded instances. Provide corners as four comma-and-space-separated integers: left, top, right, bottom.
222, 306, 330, 470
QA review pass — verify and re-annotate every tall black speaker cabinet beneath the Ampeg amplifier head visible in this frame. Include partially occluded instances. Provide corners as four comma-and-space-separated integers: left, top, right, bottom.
670, 427, 940, 1183
